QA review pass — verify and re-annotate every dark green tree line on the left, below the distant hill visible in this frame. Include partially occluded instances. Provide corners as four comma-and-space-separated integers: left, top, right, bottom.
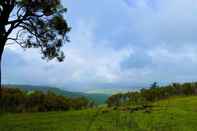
0, 87, 95, 112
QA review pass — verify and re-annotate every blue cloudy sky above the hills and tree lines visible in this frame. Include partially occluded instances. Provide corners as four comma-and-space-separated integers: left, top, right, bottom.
2, 0, 197, 92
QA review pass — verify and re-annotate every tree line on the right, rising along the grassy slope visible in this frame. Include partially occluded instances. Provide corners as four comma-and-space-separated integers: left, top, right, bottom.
107, 82, 197, 107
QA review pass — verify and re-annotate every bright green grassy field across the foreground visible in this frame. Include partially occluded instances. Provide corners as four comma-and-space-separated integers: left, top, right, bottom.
0, 96, 197, 131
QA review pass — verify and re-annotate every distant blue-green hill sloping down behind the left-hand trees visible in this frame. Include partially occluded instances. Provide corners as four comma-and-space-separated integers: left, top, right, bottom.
3, 85, 110, 104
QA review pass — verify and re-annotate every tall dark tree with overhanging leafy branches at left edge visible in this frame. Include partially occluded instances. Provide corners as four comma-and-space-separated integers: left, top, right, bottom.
0, 0, 70, 89
